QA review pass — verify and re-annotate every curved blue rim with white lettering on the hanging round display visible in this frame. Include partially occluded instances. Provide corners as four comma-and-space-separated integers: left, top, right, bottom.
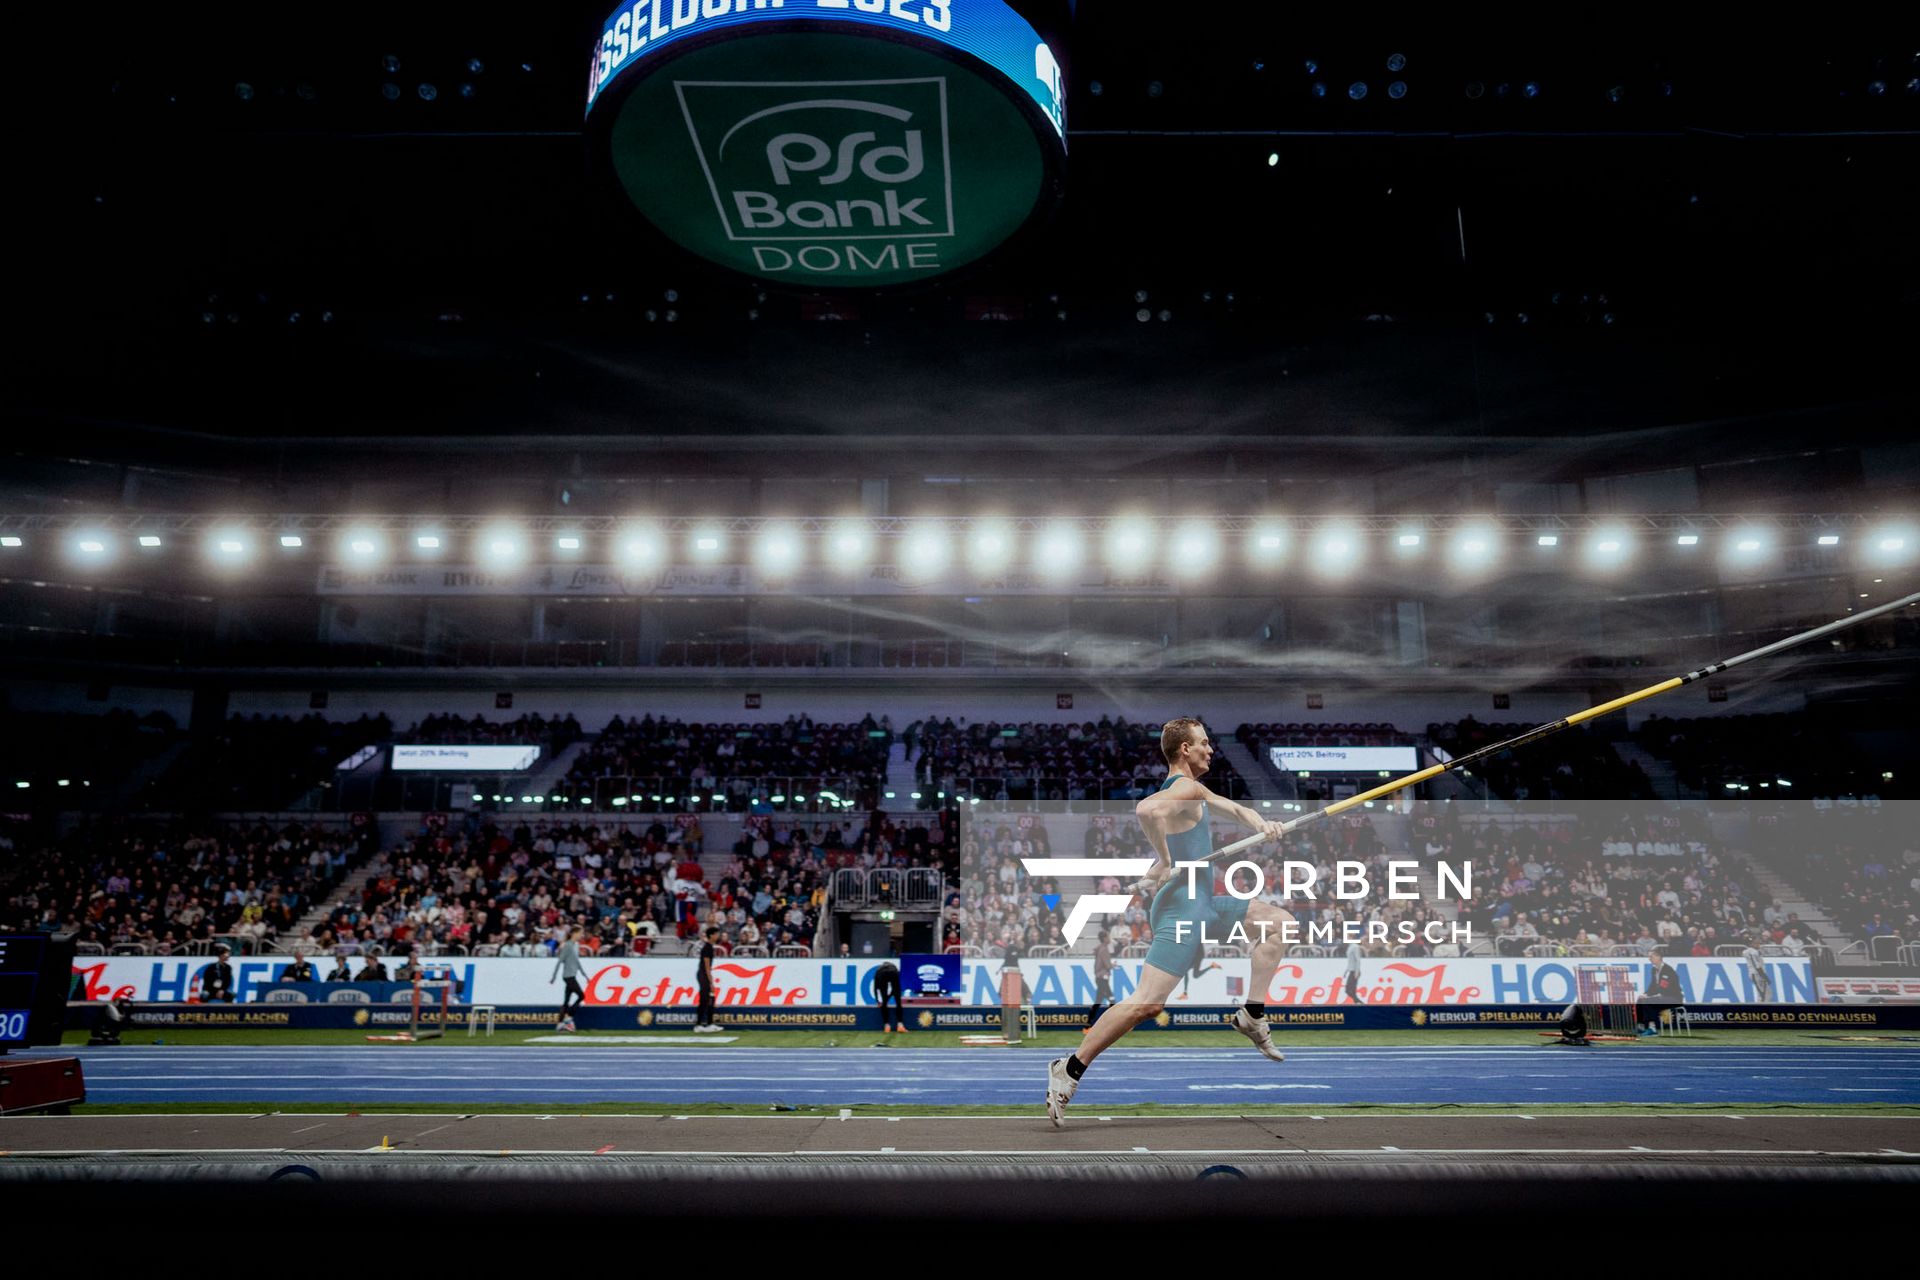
588, 0, 1068, 140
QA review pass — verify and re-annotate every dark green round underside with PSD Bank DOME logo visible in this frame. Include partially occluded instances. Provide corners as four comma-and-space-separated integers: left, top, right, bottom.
611, 33, 1046, 288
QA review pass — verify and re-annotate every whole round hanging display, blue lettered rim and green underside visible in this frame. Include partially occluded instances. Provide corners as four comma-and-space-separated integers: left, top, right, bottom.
588, 0, 1066, 290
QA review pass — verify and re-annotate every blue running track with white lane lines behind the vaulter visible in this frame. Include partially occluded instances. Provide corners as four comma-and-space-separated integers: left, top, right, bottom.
56, 1044, 1920, 1109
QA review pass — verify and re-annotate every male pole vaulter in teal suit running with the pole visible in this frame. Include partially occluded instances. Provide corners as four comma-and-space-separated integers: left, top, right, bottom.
1046, 716, 1292, 1128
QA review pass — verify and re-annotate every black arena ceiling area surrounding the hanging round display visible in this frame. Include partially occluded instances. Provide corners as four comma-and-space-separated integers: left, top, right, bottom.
8, 0, 1920, 477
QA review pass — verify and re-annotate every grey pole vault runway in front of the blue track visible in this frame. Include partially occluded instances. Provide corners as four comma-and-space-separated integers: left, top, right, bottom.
0, 1111, 1920, 1178
